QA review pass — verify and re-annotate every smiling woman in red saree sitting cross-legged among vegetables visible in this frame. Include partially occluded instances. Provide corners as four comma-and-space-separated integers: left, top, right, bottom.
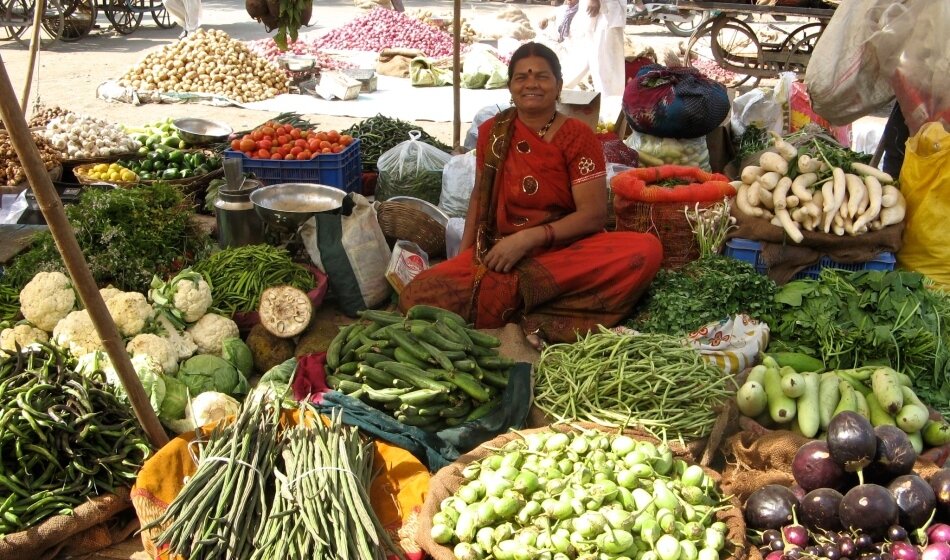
399, 43, 663, 342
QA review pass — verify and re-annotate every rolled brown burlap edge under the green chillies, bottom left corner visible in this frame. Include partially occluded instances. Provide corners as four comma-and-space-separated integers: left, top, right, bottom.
0, 488, 138, 560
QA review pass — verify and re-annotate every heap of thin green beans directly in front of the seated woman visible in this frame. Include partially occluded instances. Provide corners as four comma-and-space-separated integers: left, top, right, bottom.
534, 327, 734, 439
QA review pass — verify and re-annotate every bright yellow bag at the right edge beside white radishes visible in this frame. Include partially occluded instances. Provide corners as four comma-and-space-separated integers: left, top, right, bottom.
897, 122, 950, 289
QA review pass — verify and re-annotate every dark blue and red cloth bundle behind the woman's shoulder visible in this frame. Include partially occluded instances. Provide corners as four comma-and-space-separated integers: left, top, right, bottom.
623, 64, 731, 138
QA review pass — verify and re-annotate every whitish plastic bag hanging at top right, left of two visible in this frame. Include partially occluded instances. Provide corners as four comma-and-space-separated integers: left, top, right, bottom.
805, 0, 900, 125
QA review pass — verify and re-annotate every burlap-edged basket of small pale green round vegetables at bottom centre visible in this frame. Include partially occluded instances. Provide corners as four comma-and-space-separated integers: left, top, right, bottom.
416, 424, 748, 560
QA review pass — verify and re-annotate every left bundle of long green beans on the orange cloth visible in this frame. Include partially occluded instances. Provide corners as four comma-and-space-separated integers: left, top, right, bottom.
151, 398, 279, 560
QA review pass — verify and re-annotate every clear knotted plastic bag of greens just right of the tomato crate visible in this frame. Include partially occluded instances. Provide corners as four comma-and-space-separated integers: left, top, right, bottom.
376, 130, 451, 205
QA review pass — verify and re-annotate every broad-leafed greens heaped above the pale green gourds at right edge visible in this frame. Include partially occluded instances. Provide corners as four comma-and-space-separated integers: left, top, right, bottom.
768, 269, 950, 415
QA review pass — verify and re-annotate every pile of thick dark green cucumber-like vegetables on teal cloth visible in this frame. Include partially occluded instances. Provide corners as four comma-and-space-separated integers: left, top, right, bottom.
327, 305, 514, 431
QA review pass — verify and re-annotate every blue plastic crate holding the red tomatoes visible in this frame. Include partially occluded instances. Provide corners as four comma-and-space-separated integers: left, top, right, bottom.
224, 138, 363, 192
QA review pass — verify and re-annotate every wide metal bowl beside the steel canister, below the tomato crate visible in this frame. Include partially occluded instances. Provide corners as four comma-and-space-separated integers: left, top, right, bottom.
251, 183, 346, 231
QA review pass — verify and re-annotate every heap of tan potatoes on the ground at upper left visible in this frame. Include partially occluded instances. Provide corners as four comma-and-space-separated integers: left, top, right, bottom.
119, 29, 287, 103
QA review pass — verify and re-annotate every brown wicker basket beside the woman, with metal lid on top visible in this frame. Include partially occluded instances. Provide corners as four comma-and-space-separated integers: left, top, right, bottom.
376, 197, 448, 259
